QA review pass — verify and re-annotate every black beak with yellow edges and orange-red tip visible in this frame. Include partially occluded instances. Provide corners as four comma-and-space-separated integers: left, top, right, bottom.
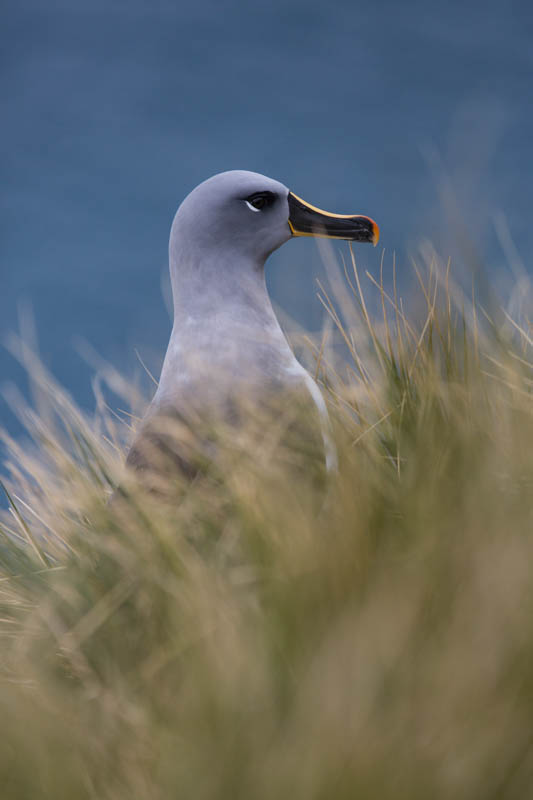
288, 192, 379, 246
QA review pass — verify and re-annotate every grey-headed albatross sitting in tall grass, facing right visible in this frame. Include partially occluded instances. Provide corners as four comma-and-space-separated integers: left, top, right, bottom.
127, 170, 379, 482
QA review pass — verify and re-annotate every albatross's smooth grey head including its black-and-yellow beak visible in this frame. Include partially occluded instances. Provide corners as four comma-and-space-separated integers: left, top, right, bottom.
170, 170, 379, 278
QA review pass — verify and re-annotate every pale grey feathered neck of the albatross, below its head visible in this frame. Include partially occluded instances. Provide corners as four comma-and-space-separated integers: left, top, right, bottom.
156, 250, 294, 412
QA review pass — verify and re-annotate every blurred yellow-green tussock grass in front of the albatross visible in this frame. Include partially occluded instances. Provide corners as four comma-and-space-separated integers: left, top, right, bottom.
0, 247, 533, 800
